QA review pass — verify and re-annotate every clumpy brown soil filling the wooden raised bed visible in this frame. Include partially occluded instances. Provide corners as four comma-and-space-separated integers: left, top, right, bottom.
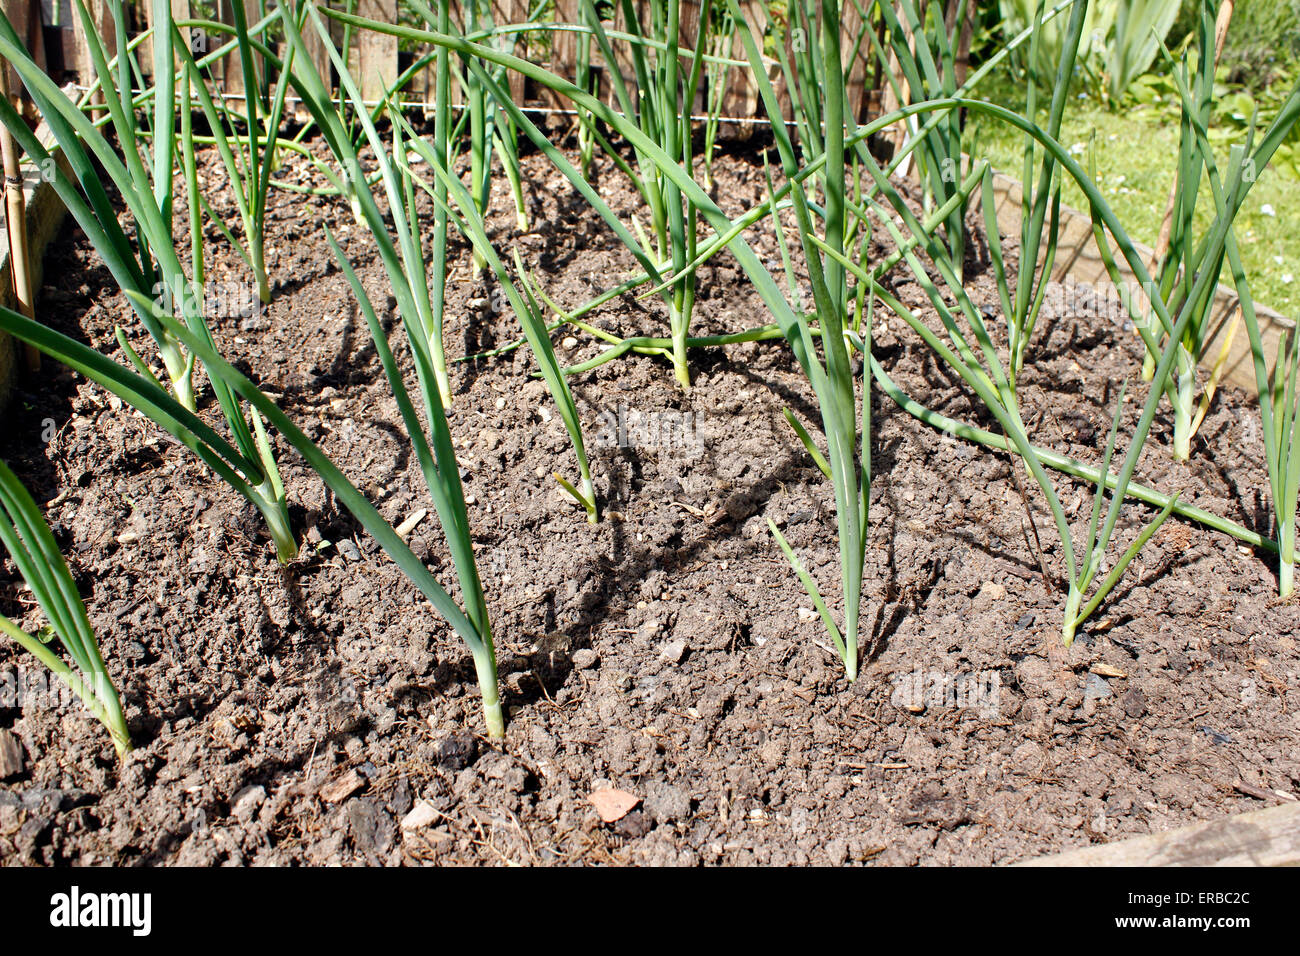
0, 127, 1300, 865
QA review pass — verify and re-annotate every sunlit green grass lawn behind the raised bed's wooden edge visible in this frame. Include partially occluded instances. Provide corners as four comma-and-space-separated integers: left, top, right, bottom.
967, 87, 1300, 319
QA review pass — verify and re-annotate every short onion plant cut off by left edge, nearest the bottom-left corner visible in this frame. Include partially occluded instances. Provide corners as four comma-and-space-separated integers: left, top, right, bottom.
0, 460, 131, 757
